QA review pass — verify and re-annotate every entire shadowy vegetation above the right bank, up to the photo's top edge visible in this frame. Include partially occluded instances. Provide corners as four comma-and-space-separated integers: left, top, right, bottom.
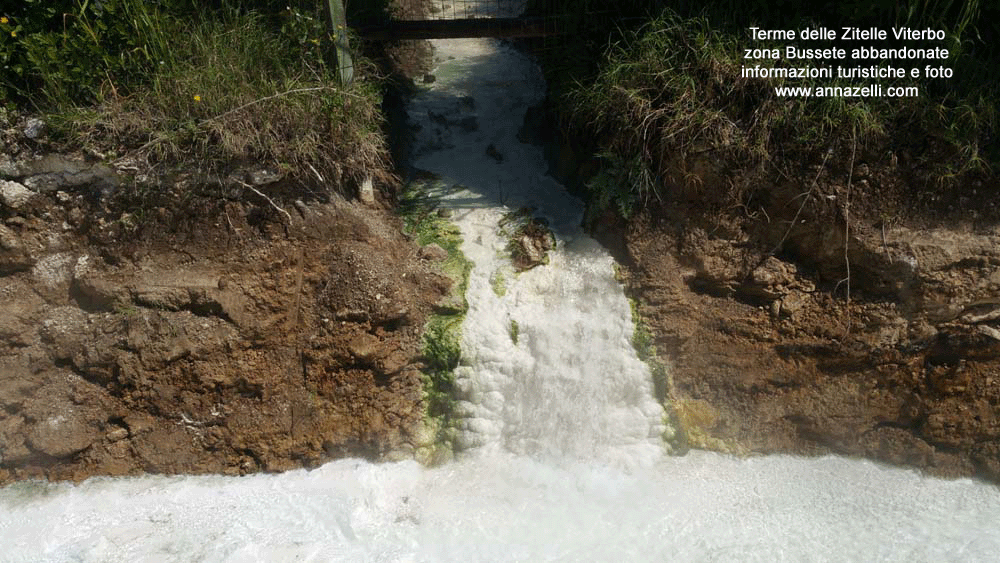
539, 0, 1000, 218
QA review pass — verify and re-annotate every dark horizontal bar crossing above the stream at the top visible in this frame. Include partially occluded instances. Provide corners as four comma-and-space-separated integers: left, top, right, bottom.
358, 18, 559, 41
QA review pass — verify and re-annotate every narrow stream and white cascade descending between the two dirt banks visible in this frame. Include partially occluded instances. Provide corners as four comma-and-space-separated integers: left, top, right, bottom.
409, 35, 667, 465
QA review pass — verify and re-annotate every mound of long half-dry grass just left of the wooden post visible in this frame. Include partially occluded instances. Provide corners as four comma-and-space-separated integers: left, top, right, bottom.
51, 7, 388, 191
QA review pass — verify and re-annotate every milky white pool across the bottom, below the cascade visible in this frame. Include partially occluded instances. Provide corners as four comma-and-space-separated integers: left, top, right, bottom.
0, 452, 1000, 563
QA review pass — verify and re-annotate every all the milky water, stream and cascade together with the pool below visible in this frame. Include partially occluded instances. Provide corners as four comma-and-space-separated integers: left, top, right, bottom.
0, 22, 1000, 563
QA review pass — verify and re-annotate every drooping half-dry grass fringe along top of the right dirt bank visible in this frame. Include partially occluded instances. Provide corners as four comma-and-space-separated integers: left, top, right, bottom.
561, 12, 1000, 218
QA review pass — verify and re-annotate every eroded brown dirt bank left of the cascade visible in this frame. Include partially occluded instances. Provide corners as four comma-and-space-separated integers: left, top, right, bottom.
0, 144, 451, 483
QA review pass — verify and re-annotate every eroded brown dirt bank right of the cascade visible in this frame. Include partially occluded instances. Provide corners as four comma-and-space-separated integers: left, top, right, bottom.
584, 153, 1000, 481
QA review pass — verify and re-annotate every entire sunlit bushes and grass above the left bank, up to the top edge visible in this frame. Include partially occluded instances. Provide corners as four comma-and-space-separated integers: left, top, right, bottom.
0, 0, 388, 192
